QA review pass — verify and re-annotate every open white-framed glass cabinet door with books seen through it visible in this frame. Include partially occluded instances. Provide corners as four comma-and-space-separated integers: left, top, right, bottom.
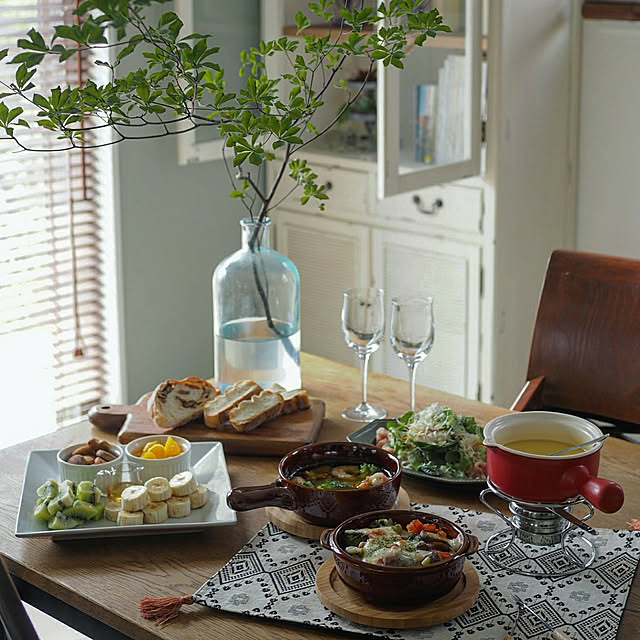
378, 0, 482, 198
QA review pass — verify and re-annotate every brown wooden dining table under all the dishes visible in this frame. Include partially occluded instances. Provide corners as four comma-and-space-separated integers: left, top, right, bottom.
0, 354, 640, 640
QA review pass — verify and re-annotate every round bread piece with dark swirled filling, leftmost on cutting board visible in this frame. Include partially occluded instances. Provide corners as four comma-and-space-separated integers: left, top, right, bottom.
147, 376, 220, 429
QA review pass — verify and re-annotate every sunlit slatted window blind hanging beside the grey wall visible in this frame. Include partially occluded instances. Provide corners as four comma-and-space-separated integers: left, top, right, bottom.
0, 0, 106, 436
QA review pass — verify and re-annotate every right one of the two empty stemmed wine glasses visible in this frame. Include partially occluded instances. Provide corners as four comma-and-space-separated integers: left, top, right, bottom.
391, 296, 435, 411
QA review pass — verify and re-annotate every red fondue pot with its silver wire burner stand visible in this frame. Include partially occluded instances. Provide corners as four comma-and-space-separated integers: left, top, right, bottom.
480, 411, 624, 578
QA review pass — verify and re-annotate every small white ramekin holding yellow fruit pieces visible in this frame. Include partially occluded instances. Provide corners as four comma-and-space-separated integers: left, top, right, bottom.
124, 435, 191, 483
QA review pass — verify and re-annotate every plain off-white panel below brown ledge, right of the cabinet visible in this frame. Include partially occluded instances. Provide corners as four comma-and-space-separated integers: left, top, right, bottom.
576, 20, 640, 258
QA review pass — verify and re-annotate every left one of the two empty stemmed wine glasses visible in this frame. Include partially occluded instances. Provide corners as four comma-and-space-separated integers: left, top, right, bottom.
342, 287, 387, 422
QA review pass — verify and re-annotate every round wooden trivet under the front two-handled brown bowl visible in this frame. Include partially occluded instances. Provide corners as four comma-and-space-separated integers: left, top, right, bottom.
316, 558, 480, 629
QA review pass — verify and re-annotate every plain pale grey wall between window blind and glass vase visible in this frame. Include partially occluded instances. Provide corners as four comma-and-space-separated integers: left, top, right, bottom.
115, 5, 252, 402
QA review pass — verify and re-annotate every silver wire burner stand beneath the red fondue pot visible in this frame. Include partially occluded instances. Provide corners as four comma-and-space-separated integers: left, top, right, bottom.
480, 480, 597, 578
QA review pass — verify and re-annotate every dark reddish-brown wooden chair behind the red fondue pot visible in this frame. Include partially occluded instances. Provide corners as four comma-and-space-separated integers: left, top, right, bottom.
511, 250, 640, 433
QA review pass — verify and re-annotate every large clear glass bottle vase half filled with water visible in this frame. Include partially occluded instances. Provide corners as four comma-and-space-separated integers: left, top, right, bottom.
212, 218, 301, 389
